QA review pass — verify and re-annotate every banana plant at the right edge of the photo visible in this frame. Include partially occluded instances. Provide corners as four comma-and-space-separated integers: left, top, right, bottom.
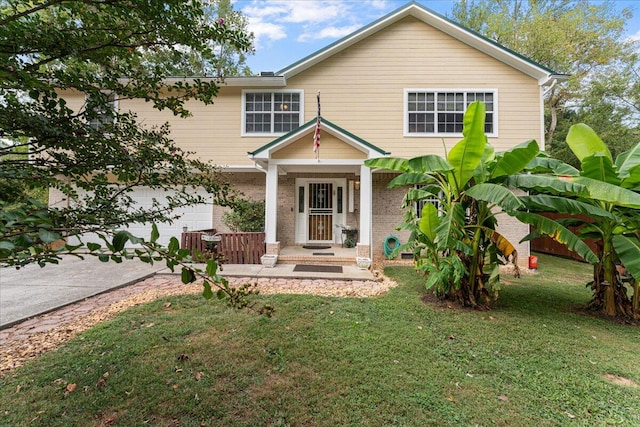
520, 124, 640, 318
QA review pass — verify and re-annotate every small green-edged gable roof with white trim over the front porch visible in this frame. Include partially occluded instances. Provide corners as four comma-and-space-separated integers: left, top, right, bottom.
247, 117, 390, 159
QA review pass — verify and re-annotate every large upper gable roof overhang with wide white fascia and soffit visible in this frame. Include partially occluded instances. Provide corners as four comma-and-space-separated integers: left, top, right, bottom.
276, 1, 568, 85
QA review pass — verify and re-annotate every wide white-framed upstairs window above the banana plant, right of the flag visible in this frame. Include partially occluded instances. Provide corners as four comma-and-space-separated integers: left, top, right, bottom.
405, 89, 497, 136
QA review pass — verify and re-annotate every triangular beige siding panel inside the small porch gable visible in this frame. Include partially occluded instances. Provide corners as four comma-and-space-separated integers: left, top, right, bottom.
271, 132, 367, 160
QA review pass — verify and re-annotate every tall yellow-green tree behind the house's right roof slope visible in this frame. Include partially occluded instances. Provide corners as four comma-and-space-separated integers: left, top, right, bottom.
452, 0, 637, 145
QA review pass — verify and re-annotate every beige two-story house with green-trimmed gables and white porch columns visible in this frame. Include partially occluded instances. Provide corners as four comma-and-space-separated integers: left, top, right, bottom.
53, 3, 564, 270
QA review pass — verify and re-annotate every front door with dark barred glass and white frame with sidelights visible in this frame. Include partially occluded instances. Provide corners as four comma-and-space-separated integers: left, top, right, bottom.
296, 179, 346, 244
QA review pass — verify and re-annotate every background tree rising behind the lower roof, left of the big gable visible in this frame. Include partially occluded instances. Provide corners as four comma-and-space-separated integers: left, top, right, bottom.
145, 0, 254, 78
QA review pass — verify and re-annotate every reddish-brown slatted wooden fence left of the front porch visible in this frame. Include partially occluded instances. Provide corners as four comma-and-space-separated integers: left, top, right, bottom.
180, 230, 266, 264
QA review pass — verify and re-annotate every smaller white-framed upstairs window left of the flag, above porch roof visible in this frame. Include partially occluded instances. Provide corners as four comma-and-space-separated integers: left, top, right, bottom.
242, 91, 303, 135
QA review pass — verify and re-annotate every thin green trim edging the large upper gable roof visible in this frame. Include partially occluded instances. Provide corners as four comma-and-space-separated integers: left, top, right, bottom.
276, 1, 565, 75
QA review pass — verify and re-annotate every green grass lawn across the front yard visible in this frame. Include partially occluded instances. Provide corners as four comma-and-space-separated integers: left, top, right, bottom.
0, 256, 640, 426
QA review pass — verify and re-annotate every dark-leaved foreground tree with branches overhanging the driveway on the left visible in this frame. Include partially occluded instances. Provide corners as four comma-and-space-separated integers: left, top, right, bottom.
0, 0, 270, 314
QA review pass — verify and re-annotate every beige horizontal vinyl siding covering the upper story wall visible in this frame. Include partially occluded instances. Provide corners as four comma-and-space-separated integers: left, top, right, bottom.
57, 17, 542, 166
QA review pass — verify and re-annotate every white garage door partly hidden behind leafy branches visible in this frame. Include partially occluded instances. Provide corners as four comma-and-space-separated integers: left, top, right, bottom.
69, 187, 213, 246
